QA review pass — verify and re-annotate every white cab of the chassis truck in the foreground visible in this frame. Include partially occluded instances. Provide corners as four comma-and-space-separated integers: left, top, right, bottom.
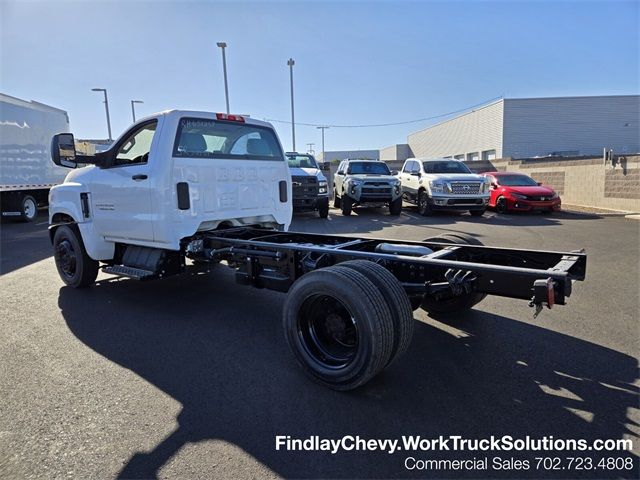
49, 110, 292, 283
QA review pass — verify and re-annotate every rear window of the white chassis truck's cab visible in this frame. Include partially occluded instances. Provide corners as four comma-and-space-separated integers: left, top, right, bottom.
173, 118, 284, 160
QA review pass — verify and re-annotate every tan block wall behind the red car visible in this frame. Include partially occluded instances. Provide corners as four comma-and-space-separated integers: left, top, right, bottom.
467, 155, 640, 212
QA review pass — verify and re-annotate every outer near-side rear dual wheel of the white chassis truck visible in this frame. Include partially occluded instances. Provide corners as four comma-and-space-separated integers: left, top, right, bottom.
283, 265, 394, 390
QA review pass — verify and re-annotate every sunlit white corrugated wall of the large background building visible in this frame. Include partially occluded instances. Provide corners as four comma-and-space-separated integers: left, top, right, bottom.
407, 100, 504, 158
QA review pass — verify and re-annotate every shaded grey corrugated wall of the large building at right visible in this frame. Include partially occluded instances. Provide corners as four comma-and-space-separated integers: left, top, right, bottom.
502, 95, 640, 158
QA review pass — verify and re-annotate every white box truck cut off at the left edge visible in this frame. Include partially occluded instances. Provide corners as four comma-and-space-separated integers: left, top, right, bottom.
0, 93, 69, 222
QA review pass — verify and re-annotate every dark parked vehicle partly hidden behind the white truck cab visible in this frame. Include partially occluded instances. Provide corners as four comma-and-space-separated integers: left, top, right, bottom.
286, 152, 329, 218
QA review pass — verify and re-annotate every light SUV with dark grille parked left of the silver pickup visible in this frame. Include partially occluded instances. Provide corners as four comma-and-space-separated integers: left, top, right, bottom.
333, 159, 402, 215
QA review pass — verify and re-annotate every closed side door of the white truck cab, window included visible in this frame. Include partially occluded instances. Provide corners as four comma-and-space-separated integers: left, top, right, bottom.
91, 119, 159, 242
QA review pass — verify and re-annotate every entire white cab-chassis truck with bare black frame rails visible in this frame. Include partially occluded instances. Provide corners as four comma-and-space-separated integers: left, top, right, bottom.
49, 111, 586, 390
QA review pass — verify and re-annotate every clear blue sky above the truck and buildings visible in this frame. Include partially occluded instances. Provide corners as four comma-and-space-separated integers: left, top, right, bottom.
0, 0, 640, 151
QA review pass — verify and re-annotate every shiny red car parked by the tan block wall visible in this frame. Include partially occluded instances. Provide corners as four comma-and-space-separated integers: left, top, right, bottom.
484, 172, 562, 213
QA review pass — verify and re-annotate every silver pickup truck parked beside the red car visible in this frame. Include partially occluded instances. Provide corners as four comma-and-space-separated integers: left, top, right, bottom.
398, 158, 489, 217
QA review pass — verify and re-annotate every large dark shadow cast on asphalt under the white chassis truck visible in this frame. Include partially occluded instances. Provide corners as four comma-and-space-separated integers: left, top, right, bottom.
59, 266, 639, 478
